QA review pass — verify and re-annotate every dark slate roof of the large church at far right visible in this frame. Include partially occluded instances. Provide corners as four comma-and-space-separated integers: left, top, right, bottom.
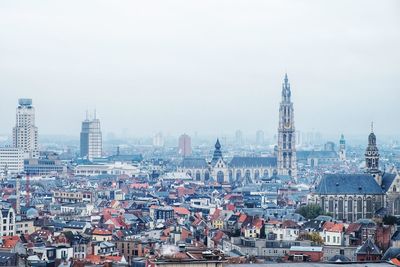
316, 174, 383, 195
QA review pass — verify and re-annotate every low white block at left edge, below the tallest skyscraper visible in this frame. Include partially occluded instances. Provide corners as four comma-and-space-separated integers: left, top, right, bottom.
0, 147, 25, 175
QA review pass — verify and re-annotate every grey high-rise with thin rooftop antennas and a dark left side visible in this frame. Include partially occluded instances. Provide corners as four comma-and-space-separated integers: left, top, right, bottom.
81, 113, 103, 160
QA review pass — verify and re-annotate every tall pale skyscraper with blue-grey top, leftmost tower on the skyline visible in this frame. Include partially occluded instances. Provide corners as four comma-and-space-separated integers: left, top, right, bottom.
13, 98, 39, 158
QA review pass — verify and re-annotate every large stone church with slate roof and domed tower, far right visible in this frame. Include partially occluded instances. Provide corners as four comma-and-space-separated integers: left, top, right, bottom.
311, 131, 400, 222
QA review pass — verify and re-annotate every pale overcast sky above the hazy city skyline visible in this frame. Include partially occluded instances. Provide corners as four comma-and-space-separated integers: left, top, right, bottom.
0, 0, 400, 136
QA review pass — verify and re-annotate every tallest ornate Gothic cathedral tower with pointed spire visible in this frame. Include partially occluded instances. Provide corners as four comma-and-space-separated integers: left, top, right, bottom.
278, 74, 297, 178
